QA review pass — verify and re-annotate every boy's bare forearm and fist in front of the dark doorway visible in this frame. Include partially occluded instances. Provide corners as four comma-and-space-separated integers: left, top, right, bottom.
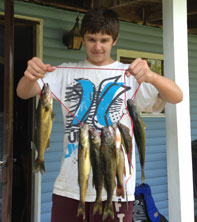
16, 57, 55, 99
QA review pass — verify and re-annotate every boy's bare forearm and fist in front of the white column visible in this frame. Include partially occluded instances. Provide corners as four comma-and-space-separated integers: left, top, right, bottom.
126, 58, 183, 104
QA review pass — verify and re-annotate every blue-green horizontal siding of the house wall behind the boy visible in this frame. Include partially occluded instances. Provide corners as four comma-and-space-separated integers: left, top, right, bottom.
0, 1, 197, 222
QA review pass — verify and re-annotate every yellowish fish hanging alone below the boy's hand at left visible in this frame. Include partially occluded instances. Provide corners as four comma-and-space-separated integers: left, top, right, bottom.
33, 83, 54, 174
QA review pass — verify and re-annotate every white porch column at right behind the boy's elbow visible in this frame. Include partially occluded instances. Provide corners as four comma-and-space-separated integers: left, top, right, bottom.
163, 0, 194, 222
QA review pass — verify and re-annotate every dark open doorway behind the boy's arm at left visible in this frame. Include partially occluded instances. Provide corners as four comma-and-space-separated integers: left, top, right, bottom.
12, 19, 35, 222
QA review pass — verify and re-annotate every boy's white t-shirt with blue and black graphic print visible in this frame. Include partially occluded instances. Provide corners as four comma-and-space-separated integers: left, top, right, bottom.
38, 60, 163, 201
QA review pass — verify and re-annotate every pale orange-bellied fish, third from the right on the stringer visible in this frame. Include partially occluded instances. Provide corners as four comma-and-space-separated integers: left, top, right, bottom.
113, 124, 126, 198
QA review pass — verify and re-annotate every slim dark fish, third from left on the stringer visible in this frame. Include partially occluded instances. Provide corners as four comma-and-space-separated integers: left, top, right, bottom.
89, 128, 104, 215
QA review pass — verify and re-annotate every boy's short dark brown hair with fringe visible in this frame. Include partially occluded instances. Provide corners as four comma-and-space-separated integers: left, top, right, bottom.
81, 8, 119, 41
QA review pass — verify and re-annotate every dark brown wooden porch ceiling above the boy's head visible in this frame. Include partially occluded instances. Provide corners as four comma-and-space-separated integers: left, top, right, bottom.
21, 0, 197, 35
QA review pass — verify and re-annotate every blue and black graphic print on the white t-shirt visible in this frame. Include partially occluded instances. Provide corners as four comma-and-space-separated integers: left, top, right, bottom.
65, 76, 130, 158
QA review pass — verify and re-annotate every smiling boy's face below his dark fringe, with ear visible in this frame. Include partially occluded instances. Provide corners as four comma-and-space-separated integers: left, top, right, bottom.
83, 32, 116, 66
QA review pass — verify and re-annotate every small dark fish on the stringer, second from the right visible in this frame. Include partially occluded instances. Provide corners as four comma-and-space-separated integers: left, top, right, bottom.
117, 122, 132, 174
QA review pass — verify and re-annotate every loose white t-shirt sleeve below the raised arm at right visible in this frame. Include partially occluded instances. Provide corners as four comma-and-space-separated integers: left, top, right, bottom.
135, 82, 166, 113
